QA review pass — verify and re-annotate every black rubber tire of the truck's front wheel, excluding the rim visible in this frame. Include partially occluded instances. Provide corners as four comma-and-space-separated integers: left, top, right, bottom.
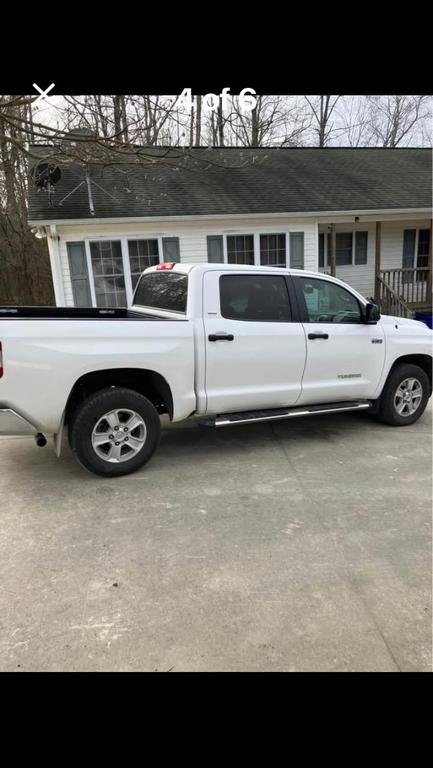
377, 363, 430, 427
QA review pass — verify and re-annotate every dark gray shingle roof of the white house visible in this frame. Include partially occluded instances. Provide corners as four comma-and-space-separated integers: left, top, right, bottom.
28, 146, 432, 221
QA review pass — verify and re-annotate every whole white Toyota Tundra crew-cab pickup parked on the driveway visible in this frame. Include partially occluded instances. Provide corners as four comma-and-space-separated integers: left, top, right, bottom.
0, 263, 433, 477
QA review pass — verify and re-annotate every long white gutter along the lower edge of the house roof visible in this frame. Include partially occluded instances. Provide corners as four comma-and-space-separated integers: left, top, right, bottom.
27, 208, 432, 227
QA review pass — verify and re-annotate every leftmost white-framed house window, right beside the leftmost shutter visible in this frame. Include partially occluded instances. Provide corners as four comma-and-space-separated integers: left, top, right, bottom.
90, 240, 127, 307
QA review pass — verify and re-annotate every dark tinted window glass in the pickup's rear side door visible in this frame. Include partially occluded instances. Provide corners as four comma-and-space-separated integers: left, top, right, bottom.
220, 275, 291, 323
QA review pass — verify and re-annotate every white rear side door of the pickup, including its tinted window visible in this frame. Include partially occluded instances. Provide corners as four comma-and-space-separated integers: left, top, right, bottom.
204, 270, 306, 414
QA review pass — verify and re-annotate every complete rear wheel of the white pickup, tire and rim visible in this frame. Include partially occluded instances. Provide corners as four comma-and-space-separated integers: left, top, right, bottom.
69, 387, 161, 477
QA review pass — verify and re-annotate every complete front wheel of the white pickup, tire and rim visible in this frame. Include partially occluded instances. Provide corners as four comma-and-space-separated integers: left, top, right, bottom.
377, 363, 430, 427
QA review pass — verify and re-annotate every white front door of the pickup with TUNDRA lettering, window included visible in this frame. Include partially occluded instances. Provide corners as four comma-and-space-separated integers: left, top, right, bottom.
294, 277, 385, 405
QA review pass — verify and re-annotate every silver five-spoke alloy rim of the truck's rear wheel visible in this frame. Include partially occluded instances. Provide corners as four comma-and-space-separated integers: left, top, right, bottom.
92, 408, 147, 464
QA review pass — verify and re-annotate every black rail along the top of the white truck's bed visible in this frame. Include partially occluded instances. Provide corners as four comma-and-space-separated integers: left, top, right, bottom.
0, 306, 171, 320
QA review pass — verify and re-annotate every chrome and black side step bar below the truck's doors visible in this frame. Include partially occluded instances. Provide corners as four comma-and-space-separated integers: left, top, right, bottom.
199, 400, 372, 427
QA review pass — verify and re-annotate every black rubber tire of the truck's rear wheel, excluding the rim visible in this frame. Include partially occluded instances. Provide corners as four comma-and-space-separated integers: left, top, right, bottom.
69, 387, 161, 477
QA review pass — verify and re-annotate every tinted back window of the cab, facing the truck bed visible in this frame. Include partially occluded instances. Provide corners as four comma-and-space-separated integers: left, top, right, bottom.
134, 272, 188, 313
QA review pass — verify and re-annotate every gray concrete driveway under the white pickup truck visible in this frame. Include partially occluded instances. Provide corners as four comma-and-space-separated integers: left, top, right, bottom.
0, 406, 432, 672
